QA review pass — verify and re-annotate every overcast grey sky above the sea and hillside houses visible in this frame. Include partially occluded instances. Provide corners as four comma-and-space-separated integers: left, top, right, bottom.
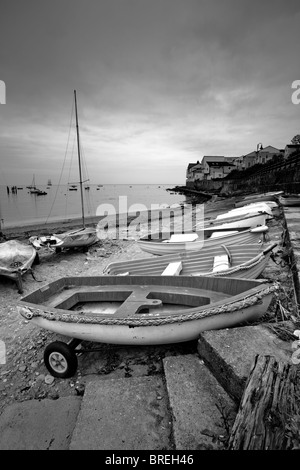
0, 0, 300, 185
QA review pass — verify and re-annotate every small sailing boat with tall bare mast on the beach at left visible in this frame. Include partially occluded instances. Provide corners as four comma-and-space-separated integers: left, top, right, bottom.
29, 90, 98, 252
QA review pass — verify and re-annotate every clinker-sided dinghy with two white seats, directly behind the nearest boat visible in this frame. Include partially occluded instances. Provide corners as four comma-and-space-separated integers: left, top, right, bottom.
105, 243, 277, 279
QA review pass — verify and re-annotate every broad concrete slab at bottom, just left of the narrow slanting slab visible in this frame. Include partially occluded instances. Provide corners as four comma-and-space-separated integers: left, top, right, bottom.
70, 376, 173, 450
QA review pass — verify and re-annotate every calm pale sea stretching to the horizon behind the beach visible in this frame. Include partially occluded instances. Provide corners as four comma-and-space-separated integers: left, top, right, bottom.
0, 184, 187, 229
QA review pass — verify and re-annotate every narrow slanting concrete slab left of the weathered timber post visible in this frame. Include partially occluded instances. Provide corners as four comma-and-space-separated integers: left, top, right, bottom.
163, 354, 236, 450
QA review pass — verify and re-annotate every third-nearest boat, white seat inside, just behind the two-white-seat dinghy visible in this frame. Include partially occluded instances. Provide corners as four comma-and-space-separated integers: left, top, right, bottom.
137, 225, 269, 255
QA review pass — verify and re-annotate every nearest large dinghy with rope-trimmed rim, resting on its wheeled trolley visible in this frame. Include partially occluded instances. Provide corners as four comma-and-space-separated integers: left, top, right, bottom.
18, 276, 277, 378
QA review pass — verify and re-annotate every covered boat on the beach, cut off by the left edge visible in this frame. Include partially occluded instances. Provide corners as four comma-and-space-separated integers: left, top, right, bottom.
0, 240, 38, 294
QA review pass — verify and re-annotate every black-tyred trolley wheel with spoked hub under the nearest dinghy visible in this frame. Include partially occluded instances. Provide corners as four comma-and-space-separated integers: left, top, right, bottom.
44, 341, 78, 379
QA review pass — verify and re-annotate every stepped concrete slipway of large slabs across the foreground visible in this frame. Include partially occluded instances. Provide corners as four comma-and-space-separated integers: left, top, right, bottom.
0, 199, 300, 451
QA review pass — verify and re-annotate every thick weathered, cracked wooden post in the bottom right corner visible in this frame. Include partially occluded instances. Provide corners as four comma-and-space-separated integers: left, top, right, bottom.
228, 355, 300, 450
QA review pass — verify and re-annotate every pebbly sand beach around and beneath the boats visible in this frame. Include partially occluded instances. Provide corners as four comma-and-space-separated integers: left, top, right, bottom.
0, 193, 296, 450
